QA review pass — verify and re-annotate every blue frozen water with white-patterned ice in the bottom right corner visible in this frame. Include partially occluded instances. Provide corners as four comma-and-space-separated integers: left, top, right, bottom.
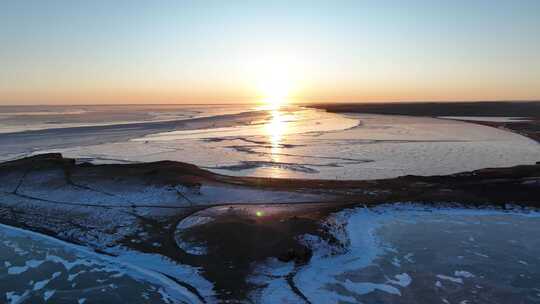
251, 205, 540, 303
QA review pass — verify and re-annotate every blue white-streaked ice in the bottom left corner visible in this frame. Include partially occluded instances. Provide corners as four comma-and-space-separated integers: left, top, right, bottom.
0, 225, 206, 304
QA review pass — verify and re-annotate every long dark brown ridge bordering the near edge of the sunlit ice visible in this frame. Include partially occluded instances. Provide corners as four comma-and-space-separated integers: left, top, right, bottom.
0, 154, 540, 206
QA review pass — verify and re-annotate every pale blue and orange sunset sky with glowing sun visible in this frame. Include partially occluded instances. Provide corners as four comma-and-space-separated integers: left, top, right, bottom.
0, 0, 540, 105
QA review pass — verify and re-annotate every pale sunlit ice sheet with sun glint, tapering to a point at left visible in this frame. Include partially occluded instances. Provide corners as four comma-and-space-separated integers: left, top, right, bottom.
34, 108, 540, 179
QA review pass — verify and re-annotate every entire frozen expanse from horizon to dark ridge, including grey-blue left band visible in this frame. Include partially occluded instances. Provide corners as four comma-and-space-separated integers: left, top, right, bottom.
0, 106, 540, 179
